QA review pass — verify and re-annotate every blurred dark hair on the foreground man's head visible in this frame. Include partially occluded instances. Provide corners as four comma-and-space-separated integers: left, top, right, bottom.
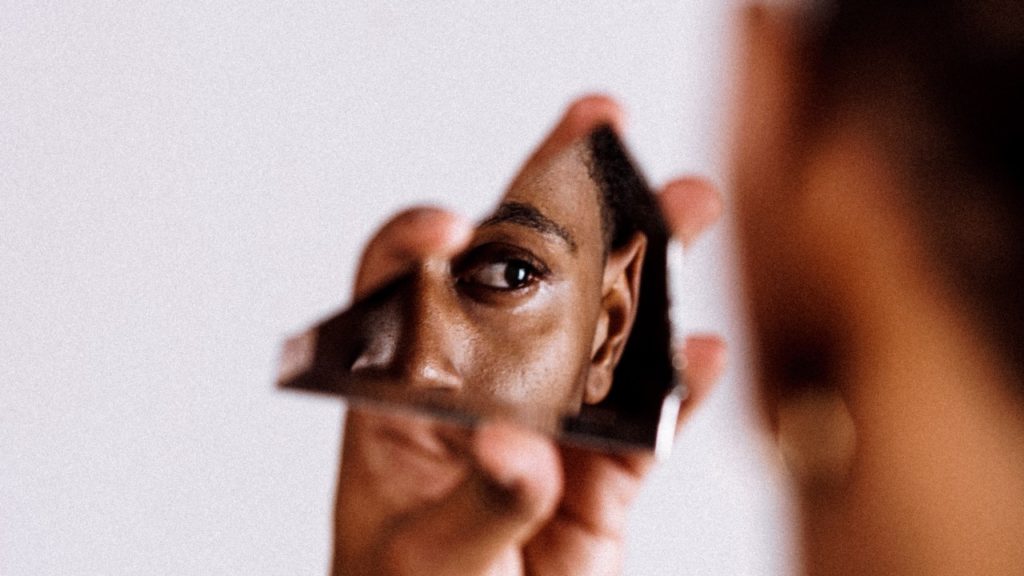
803, 0, 1024, 381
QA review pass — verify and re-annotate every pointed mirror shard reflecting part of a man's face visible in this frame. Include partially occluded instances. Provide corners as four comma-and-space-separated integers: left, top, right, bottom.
280, 126, 680, 449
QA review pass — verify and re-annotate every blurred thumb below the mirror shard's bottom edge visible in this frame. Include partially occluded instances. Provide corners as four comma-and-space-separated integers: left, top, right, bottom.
370, 423, 562, 575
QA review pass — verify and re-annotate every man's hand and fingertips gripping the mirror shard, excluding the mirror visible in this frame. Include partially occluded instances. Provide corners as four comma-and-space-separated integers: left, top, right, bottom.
335, 96, 725, 575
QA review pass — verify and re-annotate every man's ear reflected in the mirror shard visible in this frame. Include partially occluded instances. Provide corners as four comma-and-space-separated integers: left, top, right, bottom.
583, 233, 647, 404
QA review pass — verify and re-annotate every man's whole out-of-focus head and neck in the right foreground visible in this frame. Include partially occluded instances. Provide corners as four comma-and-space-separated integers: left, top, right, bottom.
736, 0, 1024, 575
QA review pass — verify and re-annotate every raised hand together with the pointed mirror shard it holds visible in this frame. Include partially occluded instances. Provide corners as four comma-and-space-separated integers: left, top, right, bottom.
268, 96, 722, 576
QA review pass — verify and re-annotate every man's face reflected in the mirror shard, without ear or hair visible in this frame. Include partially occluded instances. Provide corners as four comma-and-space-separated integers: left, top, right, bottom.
353, 142, 605, 408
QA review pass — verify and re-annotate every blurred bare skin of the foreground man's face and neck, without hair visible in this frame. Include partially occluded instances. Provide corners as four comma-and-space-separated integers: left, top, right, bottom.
735, 5, 1024, 576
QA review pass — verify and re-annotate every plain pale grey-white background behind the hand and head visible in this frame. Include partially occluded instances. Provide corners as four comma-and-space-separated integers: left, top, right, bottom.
0, 0, 795, 576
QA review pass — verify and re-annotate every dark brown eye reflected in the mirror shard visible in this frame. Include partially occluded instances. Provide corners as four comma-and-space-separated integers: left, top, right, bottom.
453, 243, 550, 294
